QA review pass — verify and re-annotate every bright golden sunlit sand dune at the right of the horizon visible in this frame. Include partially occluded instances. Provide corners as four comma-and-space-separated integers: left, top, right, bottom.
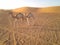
38, 6, 60, 13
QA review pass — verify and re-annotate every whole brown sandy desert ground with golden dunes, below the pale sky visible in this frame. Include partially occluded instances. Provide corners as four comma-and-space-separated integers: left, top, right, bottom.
0, 6, 60, 45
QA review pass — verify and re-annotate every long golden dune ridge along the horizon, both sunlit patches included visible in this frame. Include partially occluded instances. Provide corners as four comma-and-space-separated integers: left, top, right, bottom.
12, 6, 60, 13
